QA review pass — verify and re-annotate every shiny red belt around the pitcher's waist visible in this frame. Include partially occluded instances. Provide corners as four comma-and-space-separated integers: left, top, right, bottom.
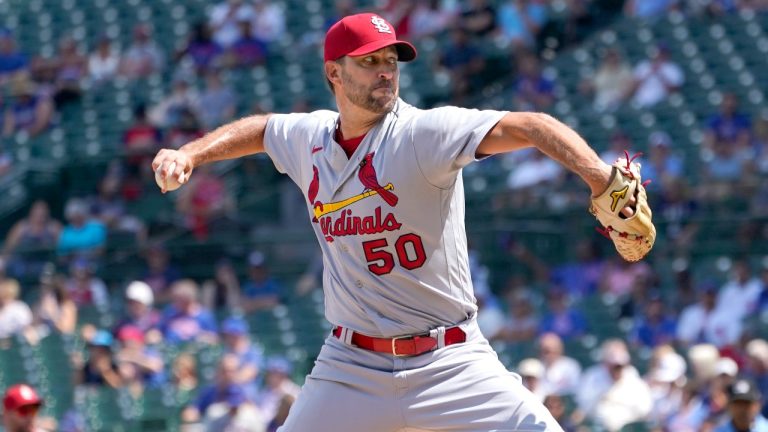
333, 327, 467, 357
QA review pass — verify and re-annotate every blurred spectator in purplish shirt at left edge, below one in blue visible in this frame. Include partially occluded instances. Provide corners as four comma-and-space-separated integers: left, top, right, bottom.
3, 76, 54, 137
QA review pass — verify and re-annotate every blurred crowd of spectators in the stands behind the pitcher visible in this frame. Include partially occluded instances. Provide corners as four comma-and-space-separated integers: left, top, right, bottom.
0, 0, 768, 431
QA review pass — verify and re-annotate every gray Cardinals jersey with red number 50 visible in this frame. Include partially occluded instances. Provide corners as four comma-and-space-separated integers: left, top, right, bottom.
264, 100, 505, 337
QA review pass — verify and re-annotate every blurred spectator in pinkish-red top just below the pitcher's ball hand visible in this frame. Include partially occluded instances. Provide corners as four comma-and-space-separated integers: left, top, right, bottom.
176, 165, 235, 240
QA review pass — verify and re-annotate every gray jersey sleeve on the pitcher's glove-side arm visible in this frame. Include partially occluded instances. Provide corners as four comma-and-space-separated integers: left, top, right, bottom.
412, 107, 506, 188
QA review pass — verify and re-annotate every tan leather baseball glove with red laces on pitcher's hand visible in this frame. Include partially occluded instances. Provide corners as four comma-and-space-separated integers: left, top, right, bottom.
589, 152, 656, 262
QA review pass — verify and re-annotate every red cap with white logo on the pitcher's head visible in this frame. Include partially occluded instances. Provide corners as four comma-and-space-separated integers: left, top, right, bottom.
324, 13, 416, 61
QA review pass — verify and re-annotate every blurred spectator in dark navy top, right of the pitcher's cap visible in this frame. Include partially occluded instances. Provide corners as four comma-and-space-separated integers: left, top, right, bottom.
438, 28, 485, 101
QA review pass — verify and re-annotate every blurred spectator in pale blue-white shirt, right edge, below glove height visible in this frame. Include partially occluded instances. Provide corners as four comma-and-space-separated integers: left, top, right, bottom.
717, 258, 762, 320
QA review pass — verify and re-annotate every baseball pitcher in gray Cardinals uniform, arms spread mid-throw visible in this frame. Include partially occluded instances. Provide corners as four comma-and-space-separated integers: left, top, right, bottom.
153, 13, 654, 432
